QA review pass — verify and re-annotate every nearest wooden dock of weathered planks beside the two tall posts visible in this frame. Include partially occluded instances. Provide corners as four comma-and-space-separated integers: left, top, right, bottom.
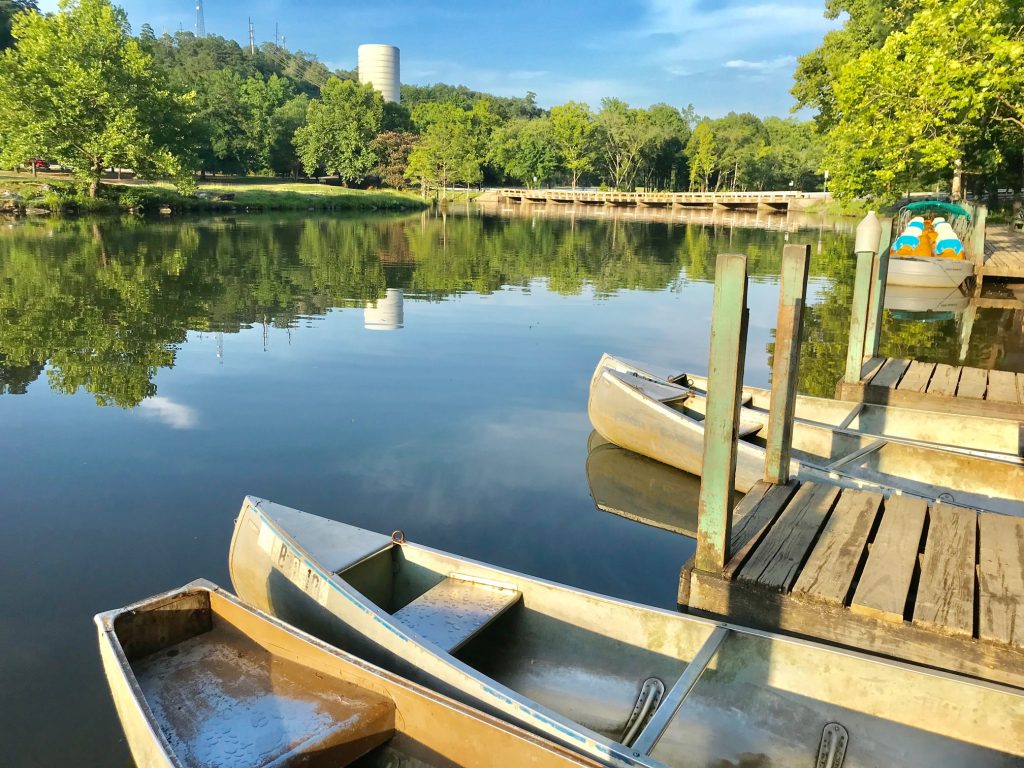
679, 481, 1024, 688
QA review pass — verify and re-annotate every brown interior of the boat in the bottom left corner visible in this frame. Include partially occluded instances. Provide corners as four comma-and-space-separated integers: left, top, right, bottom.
107, 590, 565, 768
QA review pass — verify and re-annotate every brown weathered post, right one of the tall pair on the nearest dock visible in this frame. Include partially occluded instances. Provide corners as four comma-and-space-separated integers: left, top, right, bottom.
765, 245, 811, 484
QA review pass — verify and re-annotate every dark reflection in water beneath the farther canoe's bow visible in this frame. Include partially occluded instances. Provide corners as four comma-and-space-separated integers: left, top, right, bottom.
587, 431, 743, 539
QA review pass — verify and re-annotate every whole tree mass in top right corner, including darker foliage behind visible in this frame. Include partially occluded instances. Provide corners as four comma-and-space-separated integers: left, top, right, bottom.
793, 0, 1024, 201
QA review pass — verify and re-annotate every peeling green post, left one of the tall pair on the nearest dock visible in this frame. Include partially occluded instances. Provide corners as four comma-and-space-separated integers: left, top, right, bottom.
694, 254, 748, 571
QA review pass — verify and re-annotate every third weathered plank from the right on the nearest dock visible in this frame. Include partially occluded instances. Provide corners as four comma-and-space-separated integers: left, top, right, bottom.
850, 496, 928, 622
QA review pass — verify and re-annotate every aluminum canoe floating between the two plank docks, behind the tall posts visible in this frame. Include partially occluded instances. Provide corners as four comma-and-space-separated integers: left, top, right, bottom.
588, 354, 1024, 514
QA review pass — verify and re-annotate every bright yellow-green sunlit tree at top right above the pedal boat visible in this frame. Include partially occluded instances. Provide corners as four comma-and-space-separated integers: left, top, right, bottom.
826, 0, 1024, 201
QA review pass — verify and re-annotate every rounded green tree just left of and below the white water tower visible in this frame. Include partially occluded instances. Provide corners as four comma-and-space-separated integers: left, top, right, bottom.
295, 78, 384, 184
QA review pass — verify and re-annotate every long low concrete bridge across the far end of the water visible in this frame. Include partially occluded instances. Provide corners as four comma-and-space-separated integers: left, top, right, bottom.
495, 189, 828, 213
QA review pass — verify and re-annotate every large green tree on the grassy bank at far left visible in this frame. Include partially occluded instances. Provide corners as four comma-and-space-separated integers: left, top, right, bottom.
0, 0, 191, 197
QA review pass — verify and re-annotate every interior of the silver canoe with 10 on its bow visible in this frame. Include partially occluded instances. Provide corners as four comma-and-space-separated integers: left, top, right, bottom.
338, 540, 1021, 768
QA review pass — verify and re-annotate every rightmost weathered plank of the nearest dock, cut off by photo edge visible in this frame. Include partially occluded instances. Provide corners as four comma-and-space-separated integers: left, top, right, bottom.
978, 512, 1024, 648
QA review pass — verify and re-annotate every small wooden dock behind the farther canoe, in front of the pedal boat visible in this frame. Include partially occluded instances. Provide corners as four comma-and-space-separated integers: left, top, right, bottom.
836, 357, 1024, 420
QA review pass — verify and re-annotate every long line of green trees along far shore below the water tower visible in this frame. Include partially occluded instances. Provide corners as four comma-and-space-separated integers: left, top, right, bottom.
0, 0, 823, 194
